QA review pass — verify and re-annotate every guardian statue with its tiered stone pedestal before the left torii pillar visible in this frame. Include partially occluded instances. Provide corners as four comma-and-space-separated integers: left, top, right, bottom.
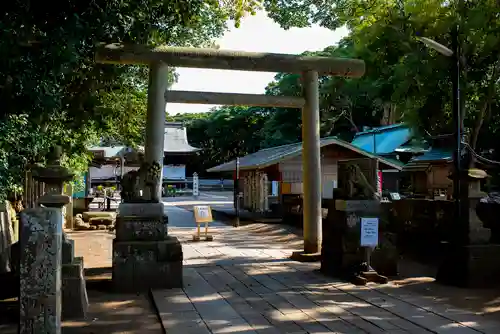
113, 162, 183, 292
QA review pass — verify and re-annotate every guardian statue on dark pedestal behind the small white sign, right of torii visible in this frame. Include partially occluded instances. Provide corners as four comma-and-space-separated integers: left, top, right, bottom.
321, 159, 387, 285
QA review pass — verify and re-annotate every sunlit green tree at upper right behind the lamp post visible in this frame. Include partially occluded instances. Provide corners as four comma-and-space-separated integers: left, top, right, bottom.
264, 0, 500, 153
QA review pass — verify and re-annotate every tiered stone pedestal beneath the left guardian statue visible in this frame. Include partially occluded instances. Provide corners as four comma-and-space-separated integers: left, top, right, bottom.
113, 203, 183, 292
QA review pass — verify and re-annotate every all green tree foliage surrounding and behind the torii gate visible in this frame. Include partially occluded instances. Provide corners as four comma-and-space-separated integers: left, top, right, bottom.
0, 0, 500, 194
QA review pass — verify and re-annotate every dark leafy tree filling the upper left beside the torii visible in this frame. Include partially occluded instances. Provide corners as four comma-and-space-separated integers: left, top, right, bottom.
0, 0, 253, 197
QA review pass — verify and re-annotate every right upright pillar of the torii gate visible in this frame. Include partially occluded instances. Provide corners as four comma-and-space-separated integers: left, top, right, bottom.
302, 71, 322, 254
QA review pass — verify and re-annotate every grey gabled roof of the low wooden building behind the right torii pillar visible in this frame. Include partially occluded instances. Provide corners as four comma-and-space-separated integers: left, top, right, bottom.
207, 137, 402, 172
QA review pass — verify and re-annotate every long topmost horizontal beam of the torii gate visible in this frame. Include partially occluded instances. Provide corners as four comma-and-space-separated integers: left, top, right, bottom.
95, 43, 365, 78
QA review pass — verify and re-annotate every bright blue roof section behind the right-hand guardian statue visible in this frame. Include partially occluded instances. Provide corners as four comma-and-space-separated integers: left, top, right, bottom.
351, 124, 412, 154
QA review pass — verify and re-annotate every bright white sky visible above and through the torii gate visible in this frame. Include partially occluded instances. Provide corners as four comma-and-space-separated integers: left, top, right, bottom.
167, 12, 348, 115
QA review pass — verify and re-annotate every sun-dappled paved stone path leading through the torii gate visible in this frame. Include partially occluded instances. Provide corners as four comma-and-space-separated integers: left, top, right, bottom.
153, 208, 500, 334
